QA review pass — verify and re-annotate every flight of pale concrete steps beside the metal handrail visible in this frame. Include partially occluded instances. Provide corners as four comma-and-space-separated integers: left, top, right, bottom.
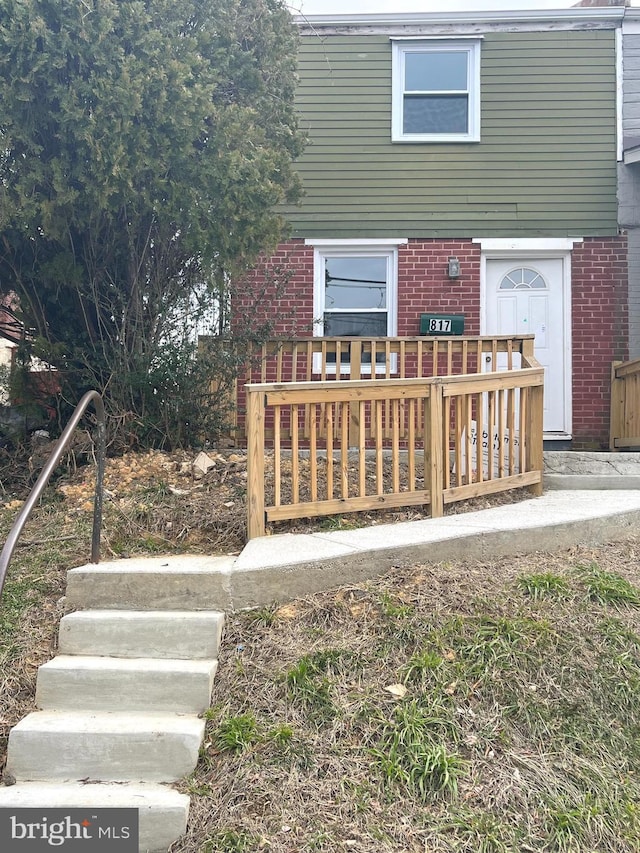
0, 557, 232, 853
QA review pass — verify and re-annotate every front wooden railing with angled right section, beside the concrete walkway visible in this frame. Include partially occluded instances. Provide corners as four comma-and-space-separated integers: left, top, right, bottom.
245, 336, 544, 539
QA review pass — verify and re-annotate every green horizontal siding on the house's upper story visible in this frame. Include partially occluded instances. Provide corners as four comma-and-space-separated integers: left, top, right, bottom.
286, 30, 617, 238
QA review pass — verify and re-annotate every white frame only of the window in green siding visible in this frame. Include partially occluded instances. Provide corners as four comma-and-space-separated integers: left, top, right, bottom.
391, 38, 482, 142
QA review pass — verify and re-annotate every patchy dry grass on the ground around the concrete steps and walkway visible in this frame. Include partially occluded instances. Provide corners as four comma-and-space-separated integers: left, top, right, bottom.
0, 446, 640, 853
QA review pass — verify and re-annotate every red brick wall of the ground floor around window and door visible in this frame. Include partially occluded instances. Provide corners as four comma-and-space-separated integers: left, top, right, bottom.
238, 236, 628, 448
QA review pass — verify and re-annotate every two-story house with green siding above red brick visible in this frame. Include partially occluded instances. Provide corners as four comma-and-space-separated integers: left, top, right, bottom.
240, 8, 640, 447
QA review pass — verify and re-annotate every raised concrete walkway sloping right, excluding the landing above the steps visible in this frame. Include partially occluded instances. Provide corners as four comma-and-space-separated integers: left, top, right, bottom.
229, 489, 640, 609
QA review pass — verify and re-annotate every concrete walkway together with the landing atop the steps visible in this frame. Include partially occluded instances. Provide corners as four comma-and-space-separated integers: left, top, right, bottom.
67, 489, 640, 612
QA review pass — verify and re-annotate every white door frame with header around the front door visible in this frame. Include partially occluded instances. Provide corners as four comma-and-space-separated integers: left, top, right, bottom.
473, 237, 582, 441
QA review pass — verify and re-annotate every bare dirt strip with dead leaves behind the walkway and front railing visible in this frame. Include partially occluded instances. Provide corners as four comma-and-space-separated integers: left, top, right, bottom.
45, 451, 529, 556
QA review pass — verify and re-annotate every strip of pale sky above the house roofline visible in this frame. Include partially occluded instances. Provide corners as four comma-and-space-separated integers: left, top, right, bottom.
288, 0, 640, 15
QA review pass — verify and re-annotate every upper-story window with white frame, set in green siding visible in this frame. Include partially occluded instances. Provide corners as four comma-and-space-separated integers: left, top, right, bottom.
391, 39, 480, 142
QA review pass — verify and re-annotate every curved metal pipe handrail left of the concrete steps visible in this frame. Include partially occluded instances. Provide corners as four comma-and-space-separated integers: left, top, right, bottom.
0, 391, 107, 596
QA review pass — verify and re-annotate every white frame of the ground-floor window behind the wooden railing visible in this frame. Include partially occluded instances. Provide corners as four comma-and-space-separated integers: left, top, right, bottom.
305, 238, 400, 375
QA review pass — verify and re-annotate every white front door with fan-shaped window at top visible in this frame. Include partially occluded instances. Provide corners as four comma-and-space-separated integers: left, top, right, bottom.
484, 255, 571, 438
